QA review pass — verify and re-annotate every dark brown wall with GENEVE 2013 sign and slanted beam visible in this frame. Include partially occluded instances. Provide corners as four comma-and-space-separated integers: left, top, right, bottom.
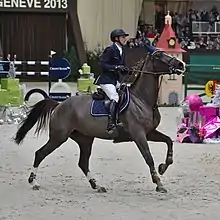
0, 0, 86, 63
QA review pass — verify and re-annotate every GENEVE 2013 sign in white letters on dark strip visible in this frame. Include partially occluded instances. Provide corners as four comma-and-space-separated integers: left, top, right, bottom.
0, 0, 68, 12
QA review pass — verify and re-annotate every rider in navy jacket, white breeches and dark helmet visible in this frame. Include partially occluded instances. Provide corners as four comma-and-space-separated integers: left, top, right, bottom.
94, 29, 129, 131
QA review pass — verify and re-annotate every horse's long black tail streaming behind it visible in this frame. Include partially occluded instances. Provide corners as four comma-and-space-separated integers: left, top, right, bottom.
14, 99, 59, 144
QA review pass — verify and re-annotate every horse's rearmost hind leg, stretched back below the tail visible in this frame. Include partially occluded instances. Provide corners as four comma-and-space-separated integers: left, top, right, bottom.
28, 136, 67, 190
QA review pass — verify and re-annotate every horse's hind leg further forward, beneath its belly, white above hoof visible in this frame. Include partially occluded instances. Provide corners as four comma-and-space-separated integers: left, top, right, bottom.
70, 131, 106, 192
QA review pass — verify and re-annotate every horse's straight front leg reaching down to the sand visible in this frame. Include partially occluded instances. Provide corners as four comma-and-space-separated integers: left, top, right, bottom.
129, 125, 167, 193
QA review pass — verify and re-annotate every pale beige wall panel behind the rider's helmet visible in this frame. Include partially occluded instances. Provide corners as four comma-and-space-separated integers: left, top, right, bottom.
77, 0, 143, 50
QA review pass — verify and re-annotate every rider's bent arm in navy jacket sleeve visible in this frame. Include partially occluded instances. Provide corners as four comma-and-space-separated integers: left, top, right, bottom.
99, 47, 117, 72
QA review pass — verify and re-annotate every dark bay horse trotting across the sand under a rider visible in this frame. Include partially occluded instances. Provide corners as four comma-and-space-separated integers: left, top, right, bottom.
15, 51, 185, 192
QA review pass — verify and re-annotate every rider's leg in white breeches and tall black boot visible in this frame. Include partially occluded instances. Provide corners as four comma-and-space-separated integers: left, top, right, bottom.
100, 84, 119, 131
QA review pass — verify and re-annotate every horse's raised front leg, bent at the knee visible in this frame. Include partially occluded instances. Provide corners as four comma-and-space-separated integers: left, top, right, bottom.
147, 130, 173, 175
